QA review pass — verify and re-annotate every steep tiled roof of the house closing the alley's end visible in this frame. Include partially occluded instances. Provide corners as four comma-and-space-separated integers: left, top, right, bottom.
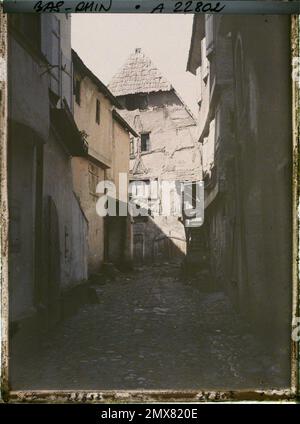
108, 48, 172, 96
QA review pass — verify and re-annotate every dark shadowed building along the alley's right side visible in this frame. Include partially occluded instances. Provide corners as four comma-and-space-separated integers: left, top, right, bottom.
187, 15, 292, 380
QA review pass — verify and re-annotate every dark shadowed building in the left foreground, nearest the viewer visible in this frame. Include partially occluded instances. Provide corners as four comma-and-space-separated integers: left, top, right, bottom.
8, 14, 88, 352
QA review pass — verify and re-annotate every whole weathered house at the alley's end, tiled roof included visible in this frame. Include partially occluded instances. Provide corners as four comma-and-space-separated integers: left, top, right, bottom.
109, 48, 202, 262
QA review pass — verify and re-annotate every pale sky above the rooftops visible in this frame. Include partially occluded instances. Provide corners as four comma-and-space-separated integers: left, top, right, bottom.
72, 13, 197, 112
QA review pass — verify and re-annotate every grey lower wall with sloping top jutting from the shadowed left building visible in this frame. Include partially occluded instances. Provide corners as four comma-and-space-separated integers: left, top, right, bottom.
43, 128, 87, 288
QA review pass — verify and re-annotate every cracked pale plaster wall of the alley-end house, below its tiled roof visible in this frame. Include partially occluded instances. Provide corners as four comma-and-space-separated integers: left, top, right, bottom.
117, 90, 202, 261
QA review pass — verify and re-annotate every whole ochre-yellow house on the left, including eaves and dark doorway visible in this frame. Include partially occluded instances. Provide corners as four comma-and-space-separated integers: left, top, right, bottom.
72, 51, 135, 275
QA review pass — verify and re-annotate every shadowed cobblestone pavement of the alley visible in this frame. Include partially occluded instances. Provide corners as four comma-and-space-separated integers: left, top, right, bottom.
12, 264, 288, 390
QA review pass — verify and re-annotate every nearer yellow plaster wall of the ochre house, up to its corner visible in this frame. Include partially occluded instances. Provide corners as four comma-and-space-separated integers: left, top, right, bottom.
72, 65, 113, 274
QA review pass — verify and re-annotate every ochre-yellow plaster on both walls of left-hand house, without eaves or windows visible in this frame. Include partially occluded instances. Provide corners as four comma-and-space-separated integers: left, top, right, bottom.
72, 62, 131, 274
